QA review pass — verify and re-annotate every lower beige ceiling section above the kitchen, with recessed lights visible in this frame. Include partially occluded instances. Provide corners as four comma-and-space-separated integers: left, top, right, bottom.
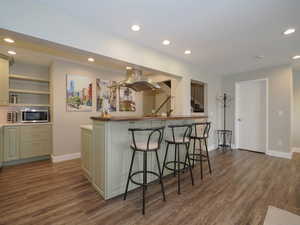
0, 28, 162, 75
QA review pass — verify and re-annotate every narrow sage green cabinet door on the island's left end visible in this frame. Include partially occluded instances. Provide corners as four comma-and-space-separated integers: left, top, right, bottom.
81, 129, 92, 177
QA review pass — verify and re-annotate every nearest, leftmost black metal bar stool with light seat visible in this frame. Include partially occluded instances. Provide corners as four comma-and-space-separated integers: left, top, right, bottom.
124, 127, 166, 214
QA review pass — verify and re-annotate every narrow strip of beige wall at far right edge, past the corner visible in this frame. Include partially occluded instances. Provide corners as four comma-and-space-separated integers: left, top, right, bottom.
293, 71, 300, 148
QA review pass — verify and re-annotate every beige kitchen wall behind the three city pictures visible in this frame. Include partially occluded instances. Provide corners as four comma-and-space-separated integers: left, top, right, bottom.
50, 61, 142, 156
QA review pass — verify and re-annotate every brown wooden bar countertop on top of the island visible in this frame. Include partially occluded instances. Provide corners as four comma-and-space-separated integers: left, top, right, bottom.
91, 116, 207, 121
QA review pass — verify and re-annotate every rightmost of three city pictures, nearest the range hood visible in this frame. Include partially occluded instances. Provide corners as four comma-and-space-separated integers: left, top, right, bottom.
119, 87, 136, 112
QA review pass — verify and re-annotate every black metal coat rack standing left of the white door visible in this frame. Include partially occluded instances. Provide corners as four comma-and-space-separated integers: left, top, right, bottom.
217, 93, 232, 151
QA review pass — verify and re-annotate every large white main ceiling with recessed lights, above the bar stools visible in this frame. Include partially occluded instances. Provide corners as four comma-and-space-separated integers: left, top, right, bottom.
24, 0, 300, 75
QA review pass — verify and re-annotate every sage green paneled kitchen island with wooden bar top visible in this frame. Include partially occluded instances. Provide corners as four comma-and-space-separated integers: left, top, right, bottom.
82, 116, 207, 199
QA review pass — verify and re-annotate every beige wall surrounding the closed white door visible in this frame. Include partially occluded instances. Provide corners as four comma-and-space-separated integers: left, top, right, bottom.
222, 66, 293, 152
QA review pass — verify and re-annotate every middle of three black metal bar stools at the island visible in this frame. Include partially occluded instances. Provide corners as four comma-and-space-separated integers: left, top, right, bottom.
162, 124, 194, 194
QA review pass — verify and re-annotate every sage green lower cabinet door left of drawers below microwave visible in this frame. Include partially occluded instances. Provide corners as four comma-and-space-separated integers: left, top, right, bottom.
4, 127, 20, 161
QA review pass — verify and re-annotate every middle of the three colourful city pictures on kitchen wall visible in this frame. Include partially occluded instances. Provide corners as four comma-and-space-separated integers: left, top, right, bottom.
96, 78, 117, 112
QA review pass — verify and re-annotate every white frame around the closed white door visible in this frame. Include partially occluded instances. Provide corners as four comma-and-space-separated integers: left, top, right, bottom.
234, 78, 269, 154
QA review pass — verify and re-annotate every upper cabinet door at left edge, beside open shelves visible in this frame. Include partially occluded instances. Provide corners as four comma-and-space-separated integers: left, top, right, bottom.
0, 58, 9, 105
